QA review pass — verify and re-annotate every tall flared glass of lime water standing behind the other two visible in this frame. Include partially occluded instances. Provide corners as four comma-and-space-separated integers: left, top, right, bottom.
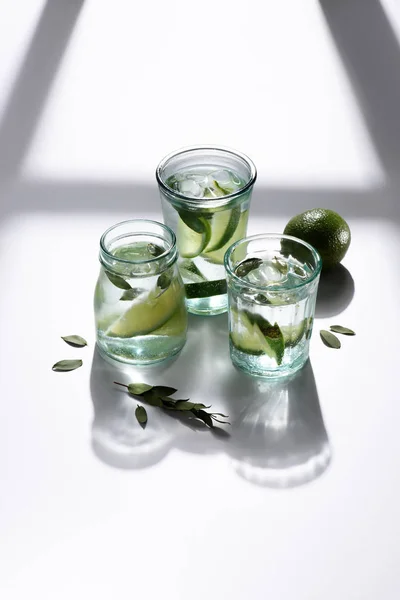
156, 146, 256, 315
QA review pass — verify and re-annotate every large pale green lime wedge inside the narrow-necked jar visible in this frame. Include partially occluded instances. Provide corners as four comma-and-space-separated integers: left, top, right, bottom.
106, 281, 183, 338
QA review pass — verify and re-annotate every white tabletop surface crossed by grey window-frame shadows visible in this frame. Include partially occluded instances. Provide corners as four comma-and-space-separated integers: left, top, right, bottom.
0, 0, 400, 600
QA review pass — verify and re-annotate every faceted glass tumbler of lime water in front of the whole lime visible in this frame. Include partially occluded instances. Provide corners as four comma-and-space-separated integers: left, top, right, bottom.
225, 234, 322, 377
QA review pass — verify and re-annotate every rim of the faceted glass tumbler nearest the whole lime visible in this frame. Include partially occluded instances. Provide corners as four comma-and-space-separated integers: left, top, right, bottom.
224, 233, 322, 292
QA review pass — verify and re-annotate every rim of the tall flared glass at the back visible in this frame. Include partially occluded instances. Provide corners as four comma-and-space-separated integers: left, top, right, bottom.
156, 144, 257, 207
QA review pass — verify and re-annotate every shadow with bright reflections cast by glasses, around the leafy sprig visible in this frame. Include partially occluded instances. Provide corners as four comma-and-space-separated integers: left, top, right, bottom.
91, 315, 331, 488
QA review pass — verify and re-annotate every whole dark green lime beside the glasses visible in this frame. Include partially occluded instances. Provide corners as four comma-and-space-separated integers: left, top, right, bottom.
283, 208, 351, 269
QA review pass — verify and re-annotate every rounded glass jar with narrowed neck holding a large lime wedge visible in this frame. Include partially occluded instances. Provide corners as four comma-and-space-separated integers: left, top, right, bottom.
94, 219, 187, 365
